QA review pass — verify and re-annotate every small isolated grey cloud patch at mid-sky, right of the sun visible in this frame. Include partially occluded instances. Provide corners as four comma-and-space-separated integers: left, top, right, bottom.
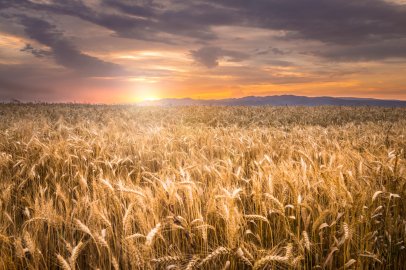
190, 47, 250, 68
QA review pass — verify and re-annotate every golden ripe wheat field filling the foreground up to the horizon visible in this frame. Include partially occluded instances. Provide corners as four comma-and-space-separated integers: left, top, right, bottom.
0, 103, 406, 270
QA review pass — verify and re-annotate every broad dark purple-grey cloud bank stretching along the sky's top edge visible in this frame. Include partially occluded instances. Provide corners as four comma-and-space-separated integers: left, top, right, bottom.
3, 0, 406, 45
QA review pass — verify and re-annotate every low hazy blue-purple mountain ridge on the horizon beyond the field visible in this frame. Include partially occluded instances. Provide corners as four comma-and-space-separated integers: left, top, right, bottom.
138, 95, 406, 107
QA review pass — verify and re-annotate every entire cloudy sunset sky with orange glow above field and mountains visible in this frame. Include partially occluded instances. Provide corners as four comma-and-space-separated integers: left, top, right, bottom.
0, 0, 406, 104
